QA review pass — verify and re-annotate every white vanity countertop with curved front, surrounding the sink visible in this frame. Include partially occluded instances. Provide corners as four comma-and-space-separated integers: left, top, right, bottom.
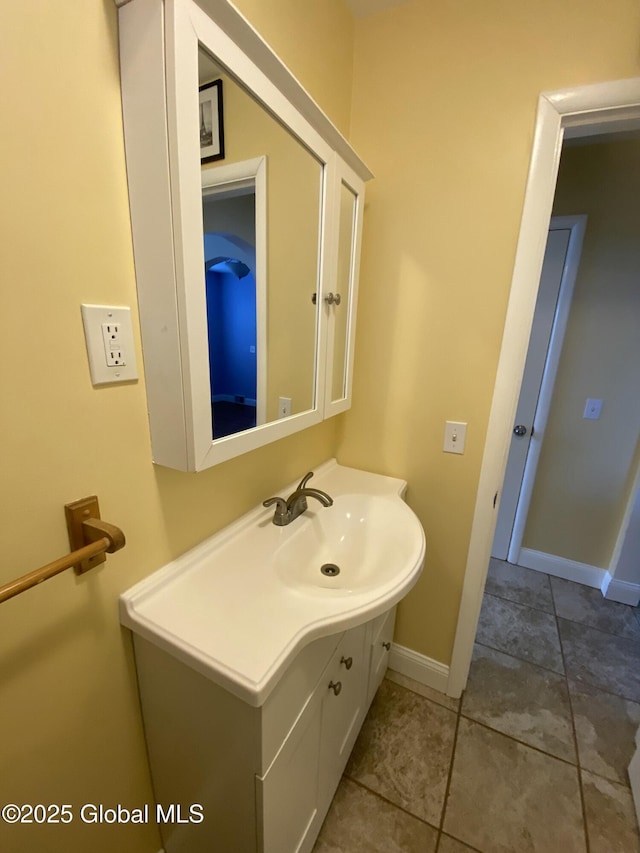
120, 460, 425, 706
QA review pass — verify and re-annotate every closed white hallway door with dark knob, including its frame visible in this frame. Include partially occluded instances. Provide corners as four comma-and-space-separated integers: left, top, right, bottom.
492, 216, 586, 562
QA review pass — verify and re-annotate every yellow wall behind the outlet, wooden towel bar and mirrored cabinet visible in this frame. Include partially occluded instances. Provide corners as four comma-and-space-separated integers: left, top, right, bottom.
0, 0, 350, 853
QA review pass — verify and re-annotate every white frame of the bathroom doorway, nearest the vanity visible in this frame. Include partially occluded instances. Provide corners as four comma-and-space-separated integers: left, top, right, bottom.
447, 78, 640, 697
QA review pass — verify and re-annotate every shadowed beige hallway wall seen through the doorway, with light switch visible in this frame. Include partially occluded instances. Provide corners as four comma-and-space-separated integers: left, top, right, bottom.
523, 140, 640, 569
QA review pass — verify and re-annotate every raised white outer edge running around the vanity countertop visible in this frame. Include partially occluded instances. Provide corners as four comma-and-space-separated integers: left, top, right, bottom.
119, 459, 426, 707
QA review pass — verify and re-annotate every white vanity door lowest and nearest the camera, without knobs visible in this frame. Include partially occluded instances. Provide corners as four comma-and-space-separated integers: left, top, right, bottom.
256, 697, 322, 853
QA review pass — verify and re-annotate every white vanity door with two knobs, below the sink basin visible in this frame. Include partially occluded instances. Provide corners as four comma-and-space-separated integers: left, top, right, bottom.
320, 625, 367, 806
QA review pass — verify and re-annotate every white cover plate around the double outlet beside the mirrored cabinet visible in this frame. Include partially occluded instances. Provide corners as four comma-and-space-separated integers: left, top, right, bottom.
81, 304, 138, 385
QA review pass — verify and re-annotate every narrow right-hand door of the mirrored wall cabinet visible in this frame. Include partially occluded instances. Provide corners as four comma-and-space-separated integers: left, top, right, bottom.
324, 157, 364, 417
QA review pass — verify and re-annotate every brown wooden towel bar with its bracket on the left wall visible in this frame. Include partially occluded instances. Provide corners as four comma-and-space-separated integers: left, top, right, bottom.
0, 495, 125, 603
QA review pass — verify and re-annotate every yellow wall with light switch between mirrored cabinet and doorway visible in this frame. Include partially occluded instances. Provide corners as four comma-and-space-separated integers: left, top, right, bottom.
339, 0, 640, 663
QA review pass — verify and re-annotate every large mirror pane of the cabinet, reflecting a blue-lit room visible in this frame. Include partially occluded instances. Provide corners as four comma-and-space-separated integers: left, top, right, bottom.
198, 46, 323, 440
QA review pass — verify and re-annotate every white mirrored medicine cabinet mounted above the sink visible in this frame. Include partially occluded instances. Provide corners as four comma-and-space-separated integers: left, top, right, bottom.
119, 0, 371, 471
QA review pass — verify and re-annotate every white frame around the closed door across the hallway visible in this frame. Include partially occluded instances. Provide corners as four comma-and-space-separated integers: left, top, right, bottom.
493, 215, 587, 563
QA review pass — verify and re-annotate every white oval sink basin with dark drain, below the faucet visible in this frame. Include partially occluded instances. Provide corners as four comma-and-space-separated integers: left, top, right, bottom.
272, 494, 415, 596
